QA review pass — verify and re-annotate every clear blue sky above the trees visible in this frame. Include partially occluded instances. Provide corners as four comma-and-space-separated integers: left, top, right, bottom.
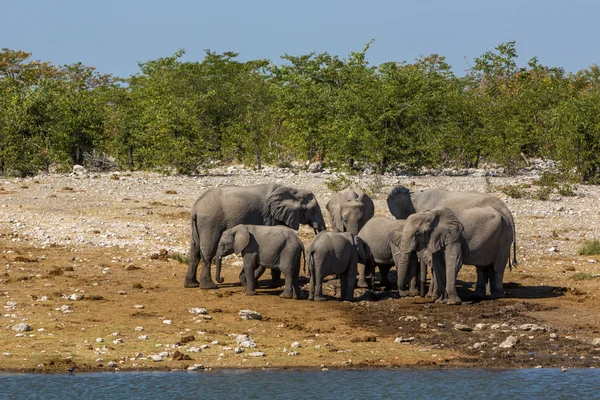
0, 0, 600, 77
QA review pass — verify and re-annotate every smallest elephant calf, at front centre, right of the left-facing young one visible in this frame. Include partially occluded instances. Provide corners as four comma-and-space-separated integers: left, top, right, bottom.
306, 231, 370, 301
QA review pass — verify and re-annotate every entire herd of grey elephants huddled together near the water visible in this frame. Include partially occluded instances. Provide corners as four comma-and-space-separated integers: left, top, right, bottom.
184, 183, 516, 304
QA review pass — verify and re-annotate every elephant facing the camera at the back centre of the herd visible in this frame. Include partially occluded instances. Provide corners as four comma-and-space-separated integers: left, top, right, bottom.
325, 188, 375, 235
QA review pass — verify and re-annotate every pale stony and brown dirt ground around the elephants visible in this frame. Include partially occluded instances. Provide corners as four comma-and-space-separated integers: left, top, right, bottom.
0, 169, 600, 372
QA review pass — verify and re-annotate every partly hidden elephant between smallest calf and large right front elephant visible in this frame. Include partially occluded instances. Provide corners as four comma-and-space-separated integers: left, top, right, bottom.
357, 215, 418, 295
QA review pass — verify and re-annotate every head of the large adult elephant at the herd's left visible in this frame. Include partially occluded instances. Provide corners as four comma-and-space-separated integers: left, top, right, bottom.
266, 186, 326, 233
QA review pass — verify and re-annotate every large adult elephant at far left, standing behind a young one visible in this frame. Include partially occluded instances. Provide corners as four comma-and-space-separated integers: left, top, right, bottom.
184, 183, 325, 289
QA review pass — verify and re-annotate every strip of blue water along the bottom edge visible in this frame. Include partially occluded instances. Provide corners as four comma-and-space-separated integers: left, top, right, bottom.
0, 369, 600, 400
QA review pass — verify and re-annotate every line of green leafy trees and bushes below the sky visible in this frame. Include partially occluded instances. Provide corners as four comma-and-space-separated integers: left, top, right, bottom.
0, 42, 600, 183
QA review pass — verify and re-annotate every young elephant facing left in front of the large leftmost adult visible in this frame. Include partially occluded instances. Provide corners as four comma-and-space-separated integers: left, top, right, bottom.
215, 225, 304, 299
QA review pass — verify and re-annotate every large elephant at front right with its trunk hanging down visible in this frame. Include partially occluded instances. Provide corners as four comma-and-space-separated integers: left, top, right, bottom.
398, 206, 514, 304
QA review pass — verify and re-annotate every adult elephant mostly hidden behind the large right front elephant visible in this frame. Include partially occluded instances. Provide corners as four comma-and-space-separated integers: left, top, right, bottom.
387, 185, 517, 265
